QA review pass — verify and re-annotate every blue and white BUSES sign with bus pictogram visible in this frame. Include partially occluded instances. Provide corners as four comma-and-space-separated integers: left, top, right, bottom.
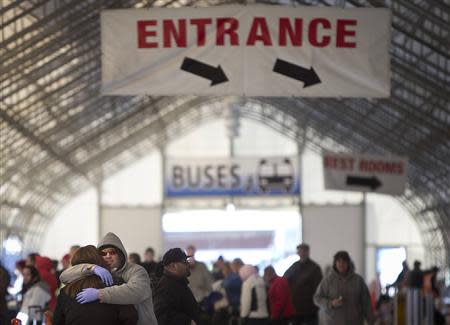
165, 157, 300, 198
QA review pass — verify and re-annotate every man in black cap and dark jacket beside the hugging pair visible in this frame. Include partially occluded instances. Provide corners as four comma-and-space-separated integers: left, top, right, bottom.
153, 248, 201, 325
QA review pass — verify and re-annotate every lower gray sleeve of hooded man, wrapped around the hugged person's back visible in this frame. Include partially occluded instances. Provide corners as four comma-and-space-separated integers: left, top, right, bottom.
99, 268, 152, 305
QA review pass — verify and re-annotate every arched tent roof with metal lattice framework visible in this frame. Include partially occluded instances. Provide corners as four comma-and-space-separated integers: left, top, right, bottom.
0, 0, 450, 267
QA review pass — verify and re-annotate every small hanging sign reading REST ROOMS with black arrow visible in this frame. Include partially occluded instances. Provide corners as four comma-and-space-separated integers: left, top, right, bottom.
323, 153, 408, 194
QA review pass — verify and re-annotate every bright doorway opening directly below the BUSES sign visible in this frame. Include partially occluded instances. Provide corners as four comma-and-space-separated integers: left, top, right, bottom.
162, 207, 301, 274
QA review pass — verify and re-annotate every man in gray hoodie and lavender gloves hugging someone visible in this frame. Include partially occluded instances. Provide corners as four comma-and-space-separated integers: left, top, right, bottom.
60, 232, 158, 325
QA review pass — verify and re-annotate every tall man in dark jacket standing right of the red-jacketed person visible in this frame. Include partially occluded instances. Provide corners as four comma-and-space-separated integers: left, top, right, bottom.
284, 243, 322, 325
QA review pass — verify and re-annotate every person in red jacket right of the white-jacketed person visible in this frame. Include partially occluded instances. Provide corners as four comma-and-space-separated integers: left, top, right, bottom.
264, 265, 294, 325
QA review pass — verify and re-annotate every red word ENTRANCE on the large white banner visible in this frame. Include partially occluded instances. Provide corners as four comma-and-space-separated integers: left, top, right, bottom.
137, 17, 357, 49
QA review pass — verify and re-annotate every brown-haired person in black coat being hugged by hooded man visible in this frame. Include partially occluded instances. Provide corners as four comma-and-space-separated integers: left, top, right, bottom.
53, 245, 138, 325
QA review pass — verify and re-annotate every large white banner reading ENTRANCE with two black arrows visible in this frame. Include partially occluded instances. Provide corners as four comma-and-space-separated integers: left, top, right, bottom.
101, 5, 390, 97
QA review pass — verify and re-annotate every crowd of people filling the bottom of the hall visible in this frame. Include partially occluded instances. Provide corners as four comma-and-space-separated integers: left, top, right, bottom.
0, 233, 445, 325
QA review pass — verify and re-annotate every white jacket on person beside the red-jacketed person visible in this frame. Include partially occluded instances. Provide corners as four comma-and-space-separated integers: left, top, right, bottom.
241, 274, 269, 318
